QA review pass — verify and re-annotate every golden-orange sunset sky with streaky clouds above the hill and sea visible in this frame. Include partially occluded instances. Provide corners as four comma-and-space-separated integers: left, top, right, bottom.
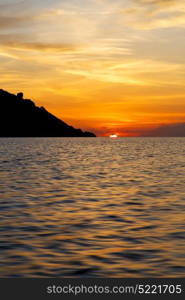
0, 0, 185, 136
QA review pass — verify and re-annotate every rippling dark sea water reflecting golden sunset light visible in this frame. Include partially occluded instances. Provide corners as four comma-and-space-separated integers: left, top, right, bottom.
0, 138, 185, 277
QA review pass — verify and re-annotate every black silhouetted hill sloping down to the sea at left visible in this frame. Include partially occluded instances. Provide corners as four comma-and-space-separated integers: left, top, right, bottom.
0, 89, 95, 137
